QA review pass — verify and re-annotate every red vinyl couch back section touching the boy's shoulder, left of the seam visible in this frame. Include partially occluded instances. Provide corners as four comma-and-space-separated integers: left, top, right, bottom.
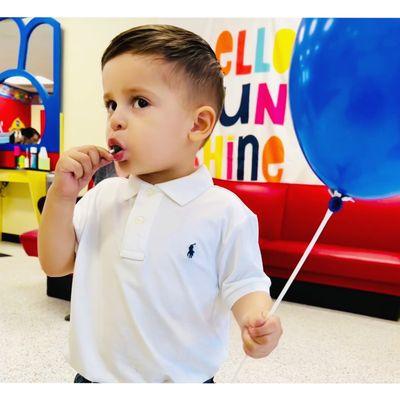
213, 178, 287, 240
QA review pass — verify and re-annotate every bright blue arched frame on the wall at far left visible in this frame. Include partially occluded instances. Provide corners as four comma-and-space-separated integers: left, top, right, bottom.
0, 18, 61, 153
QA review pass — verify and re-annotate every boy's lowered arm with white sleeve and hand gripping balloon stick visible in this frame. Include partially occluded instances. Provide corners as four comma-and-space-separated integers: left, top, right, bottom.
219, 209, 282, 358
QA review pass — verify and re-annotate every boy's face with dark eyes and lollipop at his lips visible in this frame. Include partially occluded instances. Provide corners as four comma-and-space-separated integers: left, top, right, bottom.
102, 53, 197, 179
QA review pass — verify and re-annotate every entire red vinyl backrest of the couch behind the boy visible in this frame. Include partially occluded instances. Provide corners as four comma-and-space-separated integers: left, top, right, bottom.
214, 179, 400, 252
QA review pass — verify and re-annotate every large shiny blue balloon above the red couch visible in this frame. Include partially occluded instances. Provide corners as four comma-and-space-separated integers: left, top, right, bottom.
289, 18, 400, 199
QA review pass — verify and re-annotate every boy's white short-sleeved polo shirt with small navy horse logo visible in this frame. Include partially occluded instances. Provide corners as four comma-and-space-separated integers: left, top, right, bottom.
68, 165, 271, 383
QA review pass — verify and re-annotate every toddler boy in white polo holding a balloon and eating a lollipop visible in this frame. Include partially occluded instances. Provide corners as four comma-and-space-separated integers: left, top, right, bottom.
39, 25, 282, 383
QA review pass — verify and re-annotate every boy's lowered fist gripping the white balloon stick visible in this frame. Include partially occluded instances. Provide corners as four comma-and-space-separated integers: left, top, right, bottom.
242, 312, 283, 358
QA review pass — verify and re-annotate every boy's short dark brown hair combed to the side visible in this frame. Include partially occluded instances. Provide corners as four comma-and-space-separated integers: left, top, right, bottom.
101, 25, 225, 148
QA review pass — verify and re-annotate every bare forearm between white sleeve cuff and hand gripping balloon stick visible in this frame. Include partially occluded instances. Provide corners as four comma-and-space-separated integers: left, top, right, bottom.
232, 291, 272, 330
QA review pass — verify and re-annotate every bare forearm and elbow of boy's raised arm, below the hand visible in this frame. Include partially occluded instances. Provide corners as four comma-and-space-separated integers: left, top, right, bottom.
38, 187, 76, 277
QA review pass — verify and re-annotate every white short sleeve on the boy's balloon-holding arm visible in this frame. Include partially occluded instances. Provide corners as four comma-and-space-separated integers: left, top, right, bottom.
218, 212, 271, 309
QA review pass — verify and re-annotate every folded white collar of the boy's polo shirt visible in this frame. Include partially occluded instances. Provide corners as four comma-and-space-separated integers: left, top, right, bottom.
122, 164, 214, 206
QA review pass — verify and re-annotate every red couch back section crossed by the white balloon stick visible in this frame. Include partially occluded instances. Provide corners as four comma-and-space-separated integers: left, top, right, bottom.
282, 184, 400, 252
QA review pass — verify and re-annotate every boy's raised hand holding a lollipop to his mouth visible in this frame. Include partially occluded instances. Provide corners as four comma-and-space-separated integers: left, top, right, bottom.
51, 145, 114, 200
